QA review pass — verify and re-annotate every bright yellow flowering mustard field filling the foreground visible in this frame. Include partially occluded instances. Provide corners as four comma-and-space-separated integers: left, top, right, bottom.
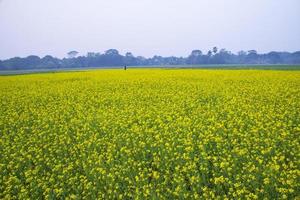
0, 69, 300, 199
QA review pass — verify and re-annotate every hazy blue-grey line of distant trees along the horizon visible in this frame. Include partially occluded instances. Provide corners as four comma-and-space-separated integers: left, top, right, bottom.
0, 47, 300, 70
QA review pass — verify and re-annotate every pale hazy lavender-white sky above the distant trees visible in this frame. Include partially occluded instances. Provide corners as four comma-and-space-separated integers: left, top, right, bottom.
0, 0, 300, 59
